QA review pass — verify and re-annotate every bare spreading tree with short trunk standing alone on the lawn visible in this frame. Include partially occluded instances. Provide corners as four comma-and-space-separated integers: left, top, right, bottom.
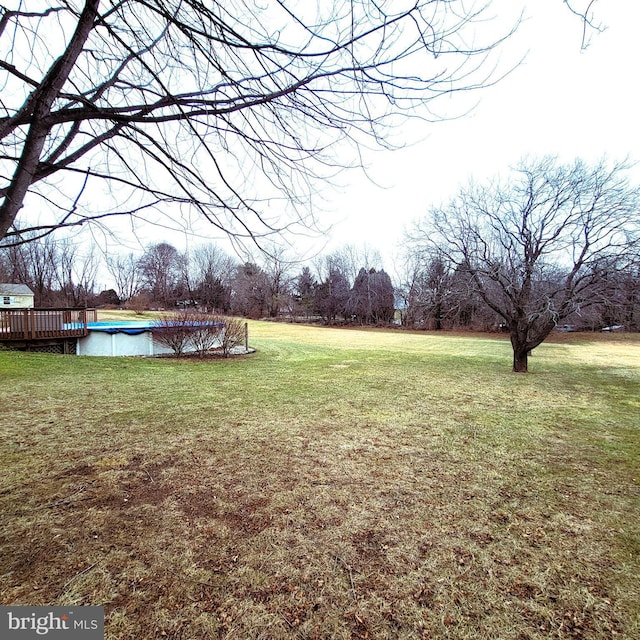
413, 158, 640, 371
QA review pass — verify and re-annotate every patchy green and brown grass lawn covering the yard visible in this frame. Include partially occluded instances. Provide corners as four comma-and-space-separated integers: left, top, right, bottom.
0, 323, 640, 640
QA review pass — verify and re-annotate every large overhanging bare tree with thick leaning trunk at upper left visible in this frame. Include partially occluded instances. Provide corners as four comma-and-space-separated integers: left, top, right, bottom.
0, 0, 517, 242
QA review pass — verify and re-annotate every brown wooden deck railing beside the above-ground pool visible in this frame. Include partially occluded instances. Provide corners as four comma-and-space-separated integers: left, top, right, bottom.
0, 308, 97, 342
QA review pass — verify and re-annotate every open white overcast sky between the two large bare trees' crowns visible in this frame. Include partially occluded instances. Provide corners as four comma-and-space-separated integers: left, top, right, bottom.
314, 0, 640, 268
